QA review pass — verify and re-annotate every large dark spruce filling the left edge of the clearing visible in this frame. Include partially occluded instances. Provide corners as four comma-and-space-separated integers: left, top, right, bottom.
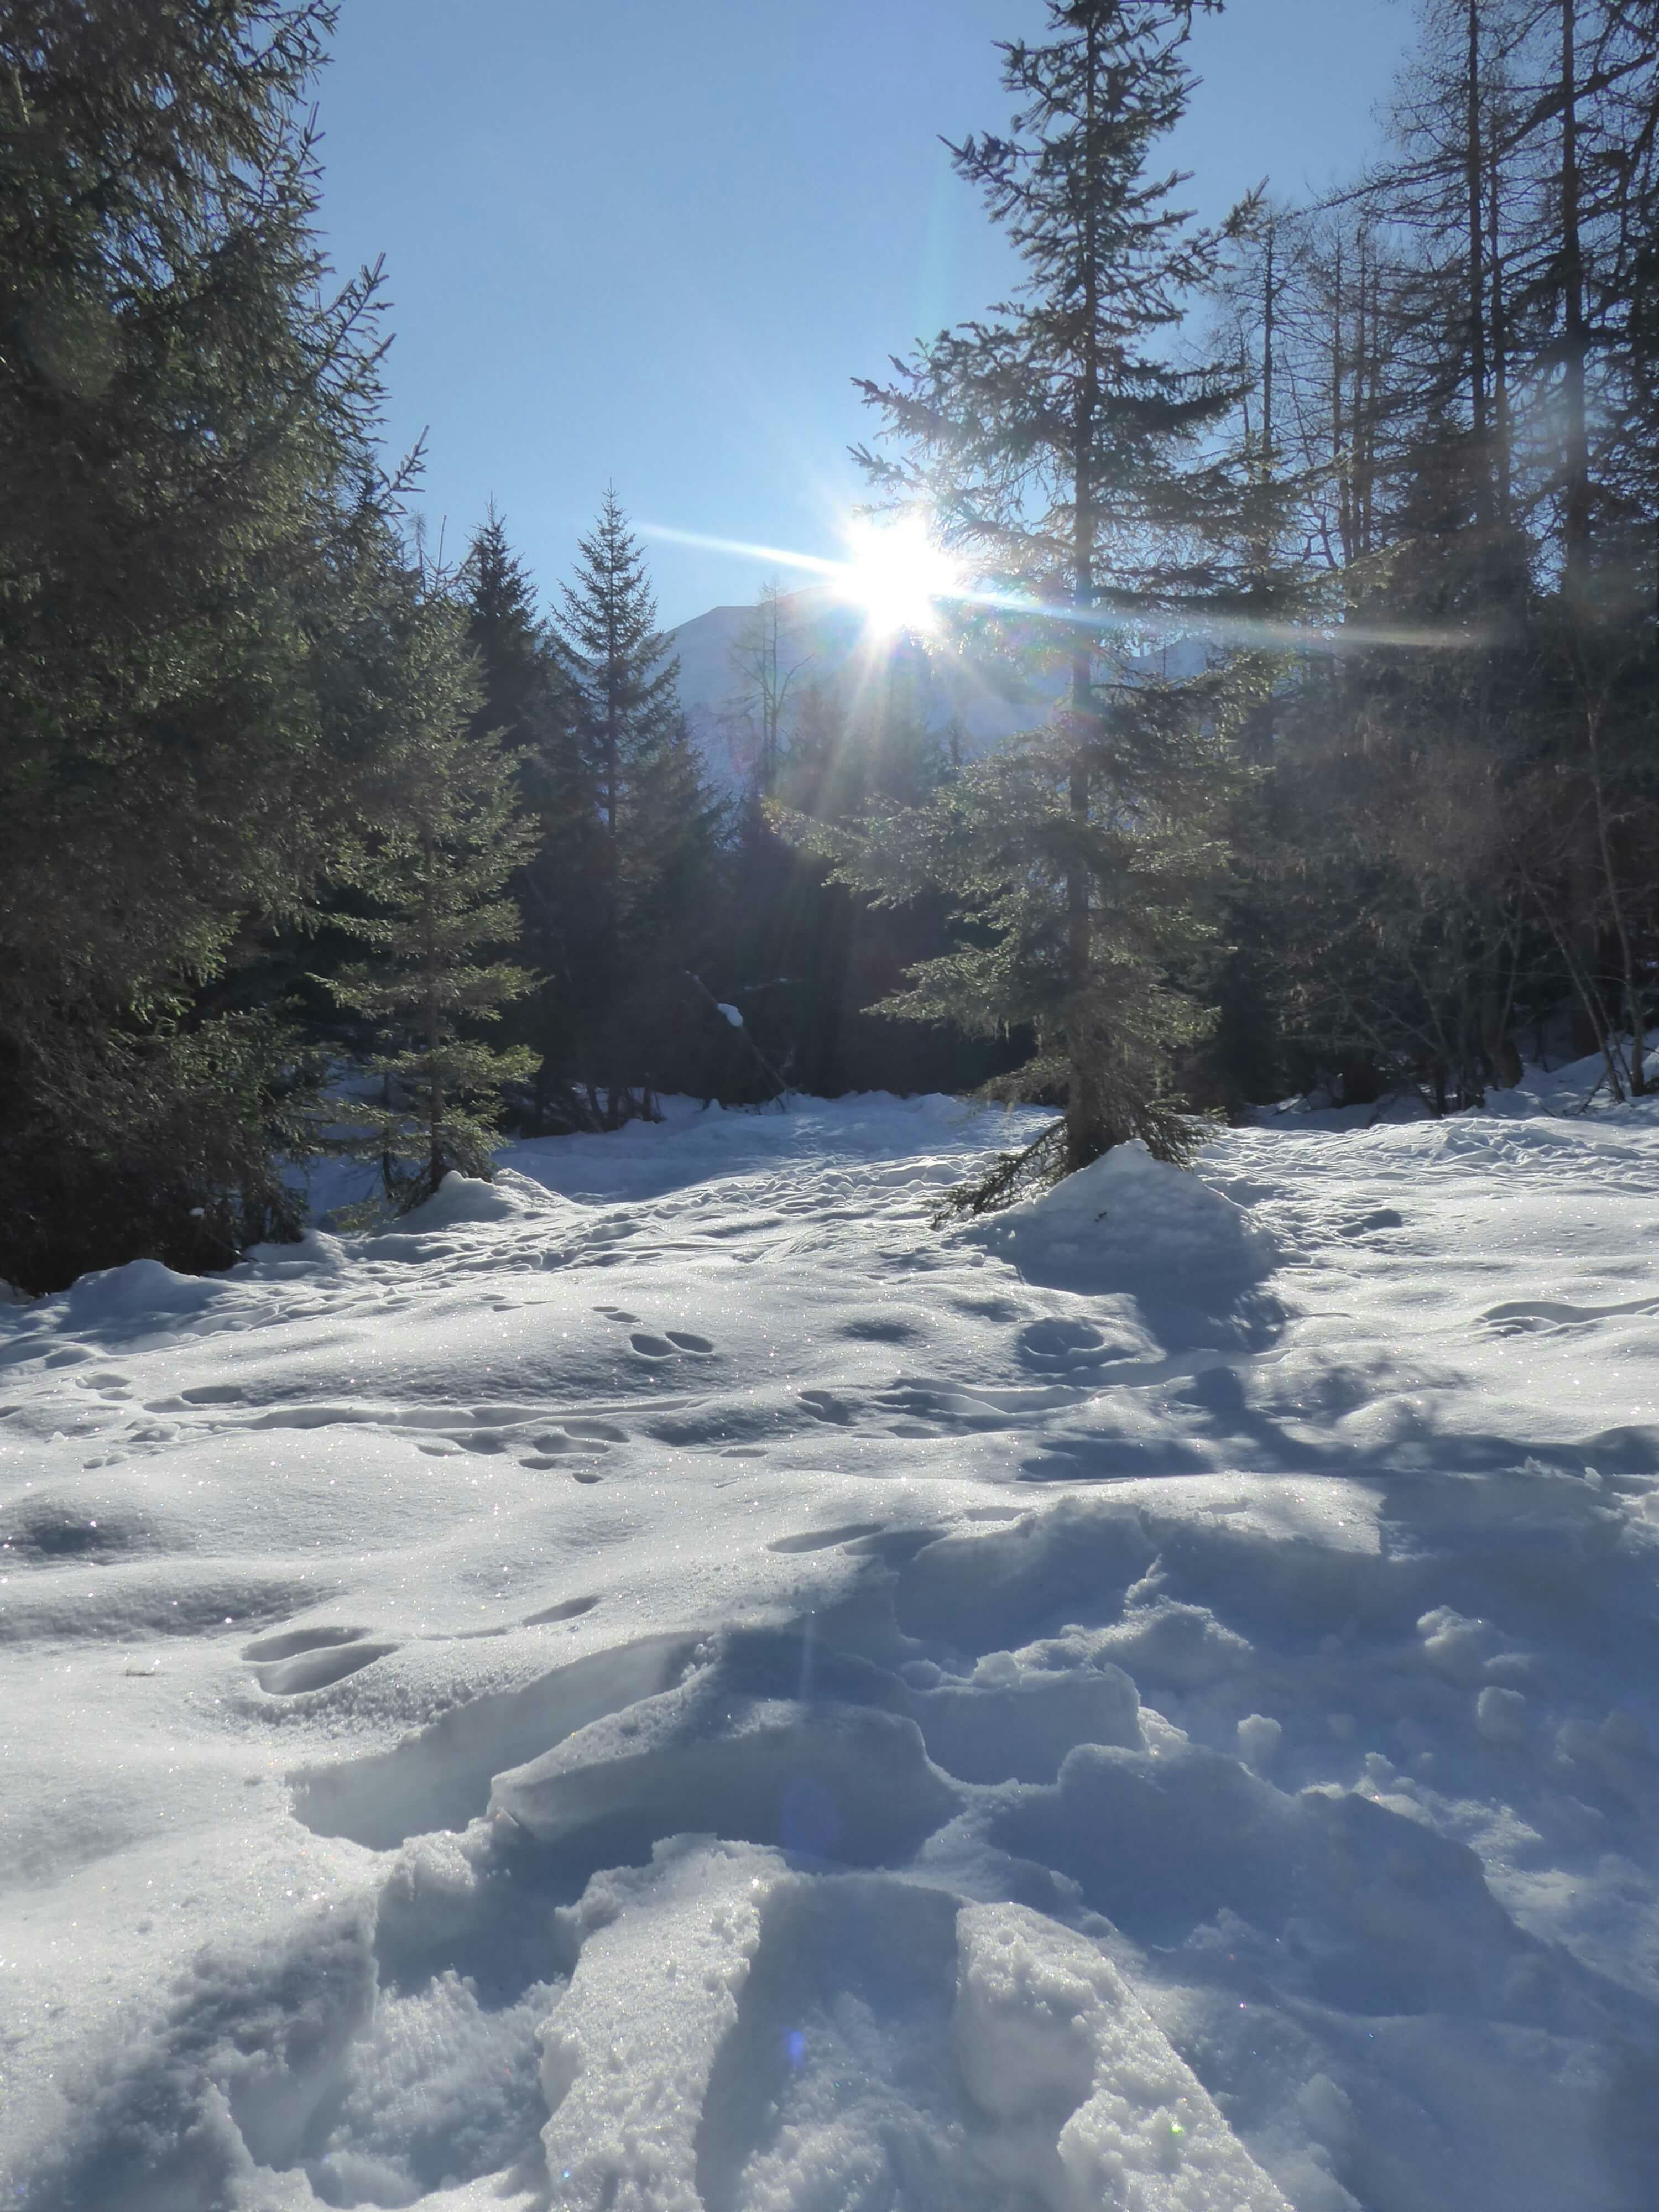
0, 0, 414, 1290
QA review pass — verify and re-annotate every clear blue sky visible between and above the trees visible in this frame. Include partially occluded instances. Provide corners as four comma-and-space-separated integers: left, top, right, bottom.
319, 0, 1411, 624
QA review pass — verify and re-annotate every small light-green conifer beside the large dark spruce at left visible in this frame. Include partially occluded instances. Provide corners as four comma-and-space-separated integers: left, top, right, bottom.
327, 593, 546, 1212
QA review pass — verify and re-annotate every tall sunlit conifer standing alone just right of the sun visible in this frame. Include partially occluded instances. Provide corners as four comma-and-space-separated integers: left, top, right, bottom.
843, 0, 1256, 1170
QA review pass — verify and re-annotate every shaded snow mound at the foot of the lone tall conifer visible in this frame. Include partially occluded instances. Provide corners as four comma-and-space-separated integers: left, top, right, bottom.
967, 1141, 1279, 1303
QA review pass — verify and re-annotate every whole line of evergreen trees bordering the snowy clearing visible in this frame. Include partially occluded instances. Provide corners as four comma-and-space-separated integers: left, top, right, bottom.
0, 0, 1659, 1292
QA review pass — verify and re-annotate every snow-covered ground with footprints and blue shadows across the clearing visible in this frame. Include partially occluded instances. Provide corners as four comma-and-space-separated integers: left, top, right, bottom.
0, 1071, 1659, 2212
